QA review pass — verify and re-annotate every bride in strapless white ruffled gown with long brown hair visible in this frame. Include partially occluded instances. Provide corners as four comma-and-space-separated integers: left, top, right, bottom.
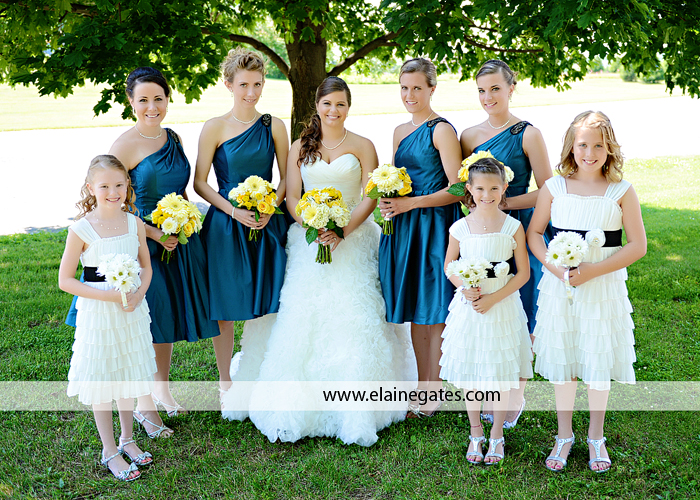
222, 77, 417, 446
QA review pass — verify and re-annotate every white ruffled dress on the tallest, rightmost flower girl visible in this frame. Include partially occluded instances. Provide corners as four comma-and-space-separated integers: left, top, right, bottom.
534, 176, 636, 390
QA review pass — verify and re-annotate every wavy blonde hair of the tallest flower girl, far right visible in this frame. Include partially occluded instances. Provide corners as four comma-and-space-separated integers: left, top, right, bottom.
556, 111, 624, 182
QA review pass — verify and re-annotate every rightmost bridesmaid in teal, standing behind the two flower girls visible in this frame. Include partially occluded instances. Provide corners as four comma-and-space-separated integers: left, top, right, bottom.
460, 59, 552, 429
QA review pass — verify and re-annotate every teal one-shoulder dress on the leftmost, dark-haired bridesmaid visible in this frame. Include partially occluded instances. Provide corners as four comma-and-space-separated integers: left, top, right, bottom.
66, 128, 219, 344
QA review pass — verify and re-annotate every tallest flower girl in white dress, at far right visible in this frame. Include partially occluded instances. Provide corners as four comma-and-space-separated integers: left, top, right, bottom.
527, 111, 647, 472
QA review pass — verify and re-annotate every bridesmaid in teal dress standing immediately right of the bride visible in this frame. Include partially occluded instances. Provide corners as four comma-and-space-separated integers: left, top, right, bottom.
379, 58, 461, 417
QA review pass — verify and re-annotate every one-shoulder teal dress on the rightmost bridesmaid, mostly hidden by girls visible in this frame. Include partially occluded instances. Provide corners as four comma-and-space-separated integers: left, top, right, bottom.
474, 121, 551, 333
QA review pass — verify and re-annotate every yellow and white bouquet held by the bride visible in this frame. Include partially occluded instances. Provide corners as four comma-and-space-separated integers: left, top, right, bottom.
296, 187, 350, 264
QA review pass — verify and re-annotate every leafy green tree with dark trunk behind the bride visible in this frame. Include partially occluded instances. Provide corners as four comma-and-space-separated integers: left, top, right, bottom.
0, 0, 700, 137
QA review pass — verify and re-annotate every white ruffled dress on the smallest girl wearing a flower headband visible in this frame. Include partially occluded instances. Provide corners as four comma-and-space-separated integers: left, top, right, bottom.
440, 216, 532, 391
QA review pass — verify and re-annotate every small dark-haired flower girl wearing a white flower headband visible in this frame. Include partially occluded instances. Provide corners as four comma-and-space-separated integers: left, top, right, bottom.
440, 158, 532, 465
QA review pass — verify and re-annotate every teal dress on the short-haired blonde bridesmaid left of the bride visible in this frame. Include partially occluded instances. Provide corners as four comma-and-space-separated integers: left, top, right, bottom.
202, 114, 288, 321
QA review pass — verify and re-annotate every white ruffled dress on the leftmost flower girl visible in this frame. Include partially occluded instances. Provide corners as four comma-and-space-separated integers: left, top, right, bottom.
68, 214, 156, 404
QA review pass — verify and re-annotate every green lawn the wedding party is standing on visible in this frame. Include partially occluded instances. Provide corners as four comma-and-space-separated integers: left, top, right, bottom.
0, 156, 700, 499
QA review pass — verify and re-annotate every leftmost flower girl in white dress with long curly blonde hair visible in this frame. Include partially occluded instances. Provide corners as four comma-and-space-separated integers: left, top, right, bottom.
58, 155, 156, 481
